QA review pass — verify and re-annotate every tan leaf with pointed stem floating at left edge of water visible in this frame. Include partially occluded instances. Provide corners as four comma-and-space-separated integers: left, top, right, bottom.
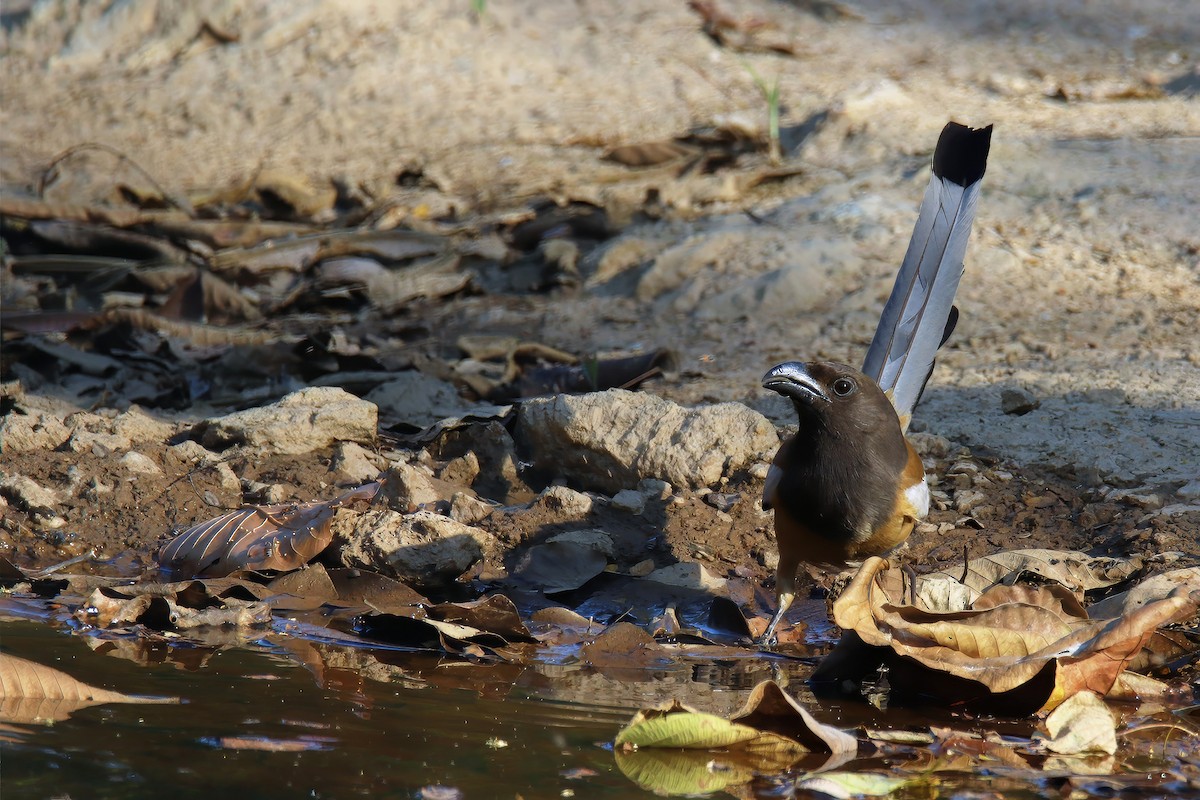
0, 652, 179, 723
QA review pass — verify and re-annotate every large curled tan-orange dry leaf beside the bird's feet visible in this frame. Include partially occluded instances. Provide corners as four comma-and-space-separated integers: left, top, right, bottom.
814, 558, 1200, 714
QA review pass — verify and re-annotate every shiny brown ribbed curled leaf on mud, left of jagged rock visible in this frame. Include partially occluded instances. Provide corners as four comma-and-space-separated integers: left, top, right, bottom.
158, 483, 379, 577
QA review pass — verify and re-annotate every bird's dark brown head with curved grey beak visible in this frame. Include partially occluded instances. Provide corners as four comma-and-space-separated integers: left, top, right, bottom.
762, 361, 899, 434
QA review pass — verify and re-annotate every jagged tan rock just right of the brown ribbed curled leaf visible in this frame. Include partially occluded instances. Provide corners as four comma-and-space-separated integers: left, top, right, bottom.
337, 509, 492, 590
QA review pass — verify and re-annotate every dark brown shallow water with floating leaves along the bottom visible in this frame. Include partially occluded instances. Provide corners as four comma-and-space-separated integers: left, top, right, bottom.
7, 597, 1181, 800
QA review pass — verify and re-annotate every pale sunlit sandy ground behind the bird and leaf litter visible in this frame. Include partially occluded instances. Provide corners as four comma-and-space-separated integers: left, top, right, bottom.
0, 0, 1200, 575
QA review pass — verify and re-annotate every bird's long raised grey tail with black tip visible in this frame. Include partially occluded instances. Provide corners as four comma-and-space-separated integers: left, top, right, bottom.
863, 122, 991, 428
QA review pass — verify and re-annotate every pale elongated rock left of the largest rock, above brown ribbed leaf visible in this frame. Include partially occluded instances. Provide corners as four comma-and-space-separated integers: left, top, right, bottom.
193, 386, 378, 456
